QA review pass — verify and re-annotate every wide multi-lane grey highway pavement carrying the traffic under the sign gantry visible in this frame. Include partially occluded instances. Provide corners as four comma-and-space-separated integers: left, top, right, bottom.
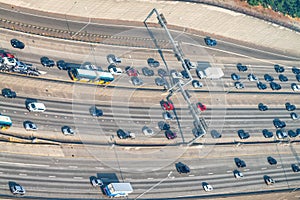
0, 5, 300, 199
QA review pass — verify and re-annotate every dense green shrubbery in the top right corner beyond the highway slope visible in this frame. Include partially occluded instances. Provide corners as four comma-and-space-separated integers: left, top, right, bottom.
247, 0, 300, 18
